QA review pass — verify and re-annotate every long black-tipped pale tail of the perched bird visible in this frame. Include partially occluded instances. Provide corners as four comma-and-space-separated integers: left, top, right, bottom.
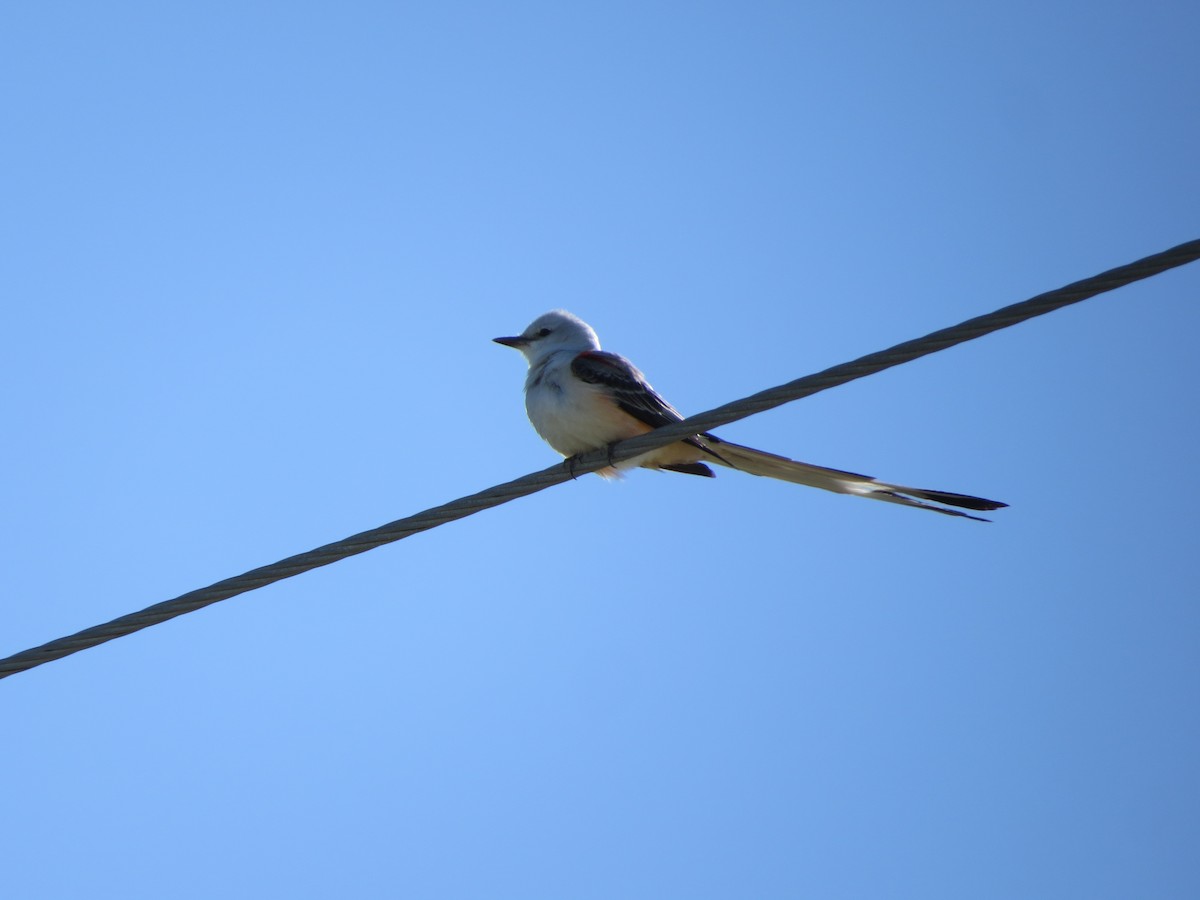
702, 434, 1008, 522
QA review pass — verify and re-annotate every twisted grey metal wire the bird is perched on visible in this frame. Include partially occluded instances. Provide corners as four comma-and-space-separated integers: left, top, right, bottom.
0, 240, 1200, 678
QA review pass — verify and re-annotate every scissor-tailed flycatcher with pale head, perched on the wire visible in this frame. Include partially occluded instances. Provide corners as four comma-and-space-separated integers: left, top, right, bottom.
496, 310, 1008, 522
